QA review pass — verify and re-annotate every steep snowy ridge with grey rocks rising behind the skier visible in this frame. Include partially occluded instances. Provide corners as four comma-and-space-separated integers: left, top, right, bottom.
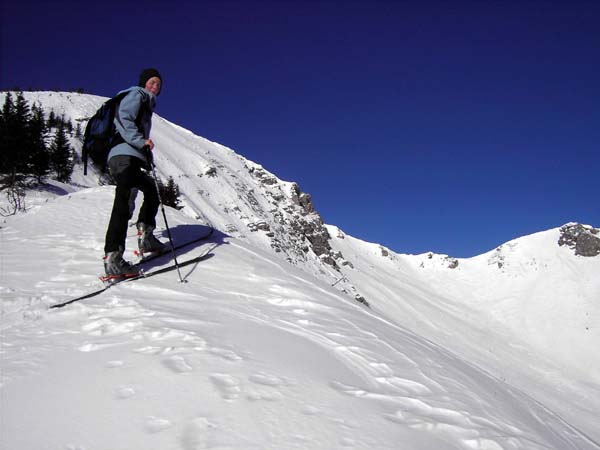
0, 92, 342, 270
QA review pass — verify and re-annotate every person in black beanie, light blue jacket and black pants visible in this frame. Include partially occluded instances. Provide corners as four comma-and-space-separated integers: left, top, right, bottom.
104, 69, 168, 280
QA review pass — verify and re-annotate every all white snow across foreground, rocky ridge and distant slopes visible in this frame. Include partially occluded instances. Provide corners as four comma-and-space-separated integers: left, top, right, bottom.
0, 93, 600, 450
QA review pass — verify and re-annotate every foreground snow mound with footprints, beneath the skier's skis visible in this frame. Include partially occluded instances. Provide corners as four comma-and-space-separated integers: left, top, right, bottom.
1, 187, 598, 450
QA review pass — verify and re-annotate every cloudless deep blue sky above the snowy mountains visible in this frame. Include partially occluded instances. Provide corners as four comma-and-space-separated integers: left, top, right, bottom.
0, 0, 600, 257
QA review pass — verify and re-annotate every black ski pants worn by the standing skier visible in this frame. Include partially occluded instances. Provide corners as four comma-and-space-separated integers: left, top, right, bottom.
104, 155, 160, 253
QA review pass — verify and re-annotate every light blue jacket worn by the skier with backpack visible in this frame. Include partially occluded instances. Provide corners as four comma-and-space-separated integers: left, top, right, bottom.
108, 86, 156, 163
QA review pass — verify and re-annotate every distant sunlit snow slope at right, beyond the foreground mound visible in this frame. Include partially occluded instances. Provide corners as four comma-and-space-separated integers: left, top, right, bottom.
329, 227, 600, 437
